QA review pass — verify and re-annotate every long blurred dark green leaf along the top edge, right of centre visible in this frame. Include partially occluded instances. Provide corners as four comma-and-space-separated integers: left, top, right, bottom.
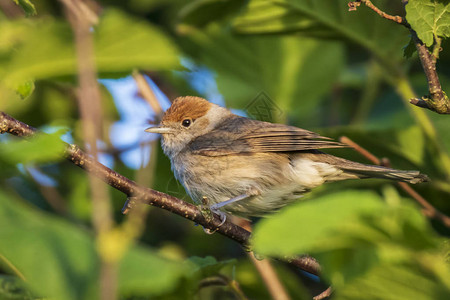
234, 0, 408, 65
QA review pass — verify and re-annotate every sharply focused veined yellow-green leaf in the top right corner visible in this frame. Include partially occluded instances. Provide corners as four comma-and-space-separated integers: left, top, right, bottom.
405, 0, 450, 47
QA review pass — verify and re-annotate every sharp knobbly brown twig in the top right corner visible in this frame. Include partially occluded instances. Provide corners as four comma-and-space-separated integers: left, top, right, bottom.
348, 0, 450, 114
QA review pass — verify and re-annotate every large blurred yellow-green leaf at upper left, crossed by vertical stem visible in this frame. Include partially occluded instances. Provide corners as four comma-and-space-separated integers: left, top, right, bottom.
0, 9, 178, 94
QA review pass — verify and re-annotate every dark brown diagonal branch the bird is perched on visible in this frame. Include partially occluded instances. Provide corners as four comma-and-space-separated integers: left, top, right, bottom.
0, 112, 320, 275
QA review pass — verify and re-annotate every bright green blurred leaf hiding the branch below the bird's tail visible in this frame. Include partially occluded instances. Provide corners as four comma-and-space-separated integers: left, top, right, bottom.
253, 191, 383, 255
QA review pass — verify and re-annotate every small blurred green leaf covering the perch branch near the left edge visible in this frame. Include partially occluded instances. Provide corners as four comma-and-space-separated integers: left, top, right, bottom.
0, 130, 66, 164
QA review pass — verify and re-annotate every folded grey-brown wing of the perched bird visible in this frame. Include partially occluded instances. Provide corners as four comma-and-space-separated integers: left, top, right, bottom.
188, 117, 348, 156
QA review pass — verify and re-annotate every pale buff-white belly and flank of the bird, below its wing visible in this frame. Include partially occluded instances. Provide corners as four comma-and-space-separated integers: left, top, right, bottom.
172, 155, 342, 216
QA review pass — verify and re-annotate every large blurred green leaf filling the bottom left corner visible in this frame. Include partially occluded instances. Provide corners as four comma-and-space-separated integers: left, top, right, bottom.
0, 193, 99, 299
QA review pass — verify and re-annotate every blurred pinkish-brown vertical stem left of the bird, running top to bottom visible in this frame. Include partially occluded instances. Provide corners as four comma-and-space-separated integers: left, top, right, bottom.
61, 0, 118, 300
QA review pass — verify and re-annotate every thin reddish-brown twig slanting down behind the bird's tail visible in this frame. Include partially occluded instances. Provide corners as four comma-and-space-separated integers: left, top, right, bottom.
339, 136, 450, 227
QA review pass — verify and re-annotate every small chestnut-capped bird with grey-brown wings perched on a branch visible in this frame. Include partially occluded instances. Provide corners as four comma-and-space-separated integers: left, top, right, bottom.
146, 96, 428, 217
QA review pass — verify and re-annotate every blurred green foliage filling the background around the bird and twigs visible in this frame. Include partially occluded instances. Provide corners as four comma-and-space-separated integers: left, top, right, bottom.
0, 0, 450, 300
